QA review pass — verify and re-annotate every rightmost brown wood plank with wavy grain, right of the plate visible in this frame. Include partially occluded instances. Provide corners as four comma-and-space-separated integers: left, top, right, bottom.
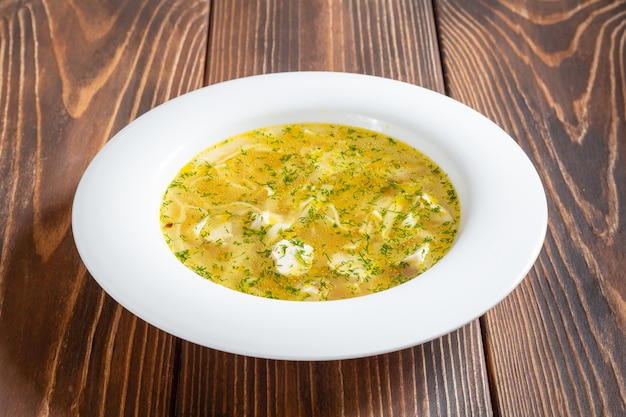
436, 0, 626, 416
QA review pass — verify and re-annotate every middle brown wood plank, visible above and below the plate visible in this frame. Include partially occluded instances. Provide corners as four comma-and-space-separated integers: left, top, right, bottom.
177, 0, 491, 416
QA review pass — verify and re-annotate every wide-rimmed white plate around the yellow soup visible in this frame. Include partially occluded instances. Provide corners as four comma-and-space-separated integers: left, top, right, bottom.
72, 72, 547, 360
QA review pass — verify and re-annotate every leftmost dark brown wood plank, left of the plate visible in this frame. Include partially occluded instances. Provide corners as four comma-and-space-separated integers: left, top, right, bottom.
0, 0, 208, 416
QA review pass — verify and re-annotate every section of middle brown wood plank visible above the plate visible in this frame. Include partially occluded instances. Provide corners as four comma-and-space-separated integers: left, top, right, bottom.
206, 0, 443, 91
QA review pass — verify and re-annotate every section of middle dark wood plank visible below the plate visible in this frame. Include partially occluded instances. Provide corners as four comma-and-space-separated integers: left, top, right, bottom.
177, 321, 491, 417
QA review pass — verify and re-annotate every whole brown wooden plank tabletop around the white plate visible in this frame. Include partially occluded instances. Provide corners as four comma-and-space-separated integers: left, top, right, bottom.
0, 0, 626, 417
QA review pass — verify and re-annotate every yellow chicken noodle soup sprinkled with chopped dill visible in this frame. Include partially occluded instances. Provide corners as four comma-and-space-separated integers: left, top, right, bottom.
160, 123, 460, 301
